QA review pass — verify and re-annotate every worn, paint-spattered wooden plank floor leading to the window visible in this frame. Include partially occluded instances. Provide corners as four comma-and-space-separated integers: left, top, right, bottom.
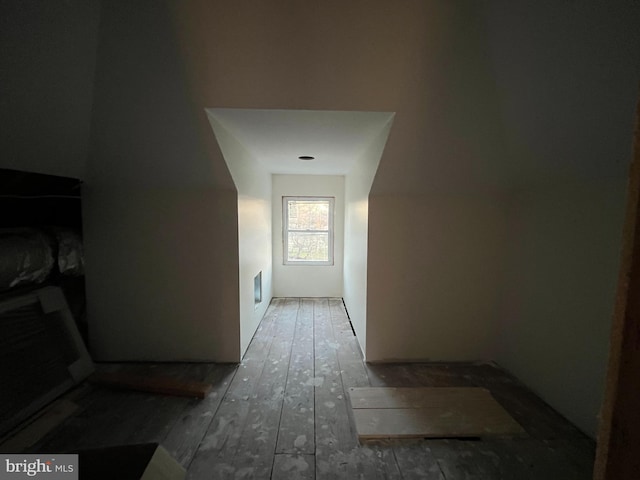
32, 298, 595, 480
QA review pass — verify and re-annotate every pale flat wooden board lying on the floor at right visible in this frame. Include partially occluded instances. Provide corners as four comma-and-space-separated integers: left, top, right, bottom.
349, 387, 524, 439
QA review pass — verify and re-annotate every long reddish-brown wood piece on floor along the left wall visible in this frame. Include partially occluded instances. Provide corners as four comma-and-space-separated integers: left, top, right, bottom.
89, 372, 212, 398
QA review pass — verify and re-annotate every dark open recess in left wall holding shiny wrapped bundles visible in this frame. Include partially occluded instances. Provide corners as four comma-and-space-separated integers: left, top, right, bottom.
0, 168, 88, 342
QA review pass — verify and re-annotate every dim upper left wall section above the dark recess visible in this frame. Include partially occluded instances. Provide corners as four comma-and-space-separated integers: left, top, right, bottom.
0, 0, 100, 178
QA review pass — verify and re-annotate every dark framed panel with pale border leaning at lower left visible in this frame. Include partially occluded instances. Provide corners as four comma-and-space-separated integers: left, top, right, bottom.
0, 287, 93, 435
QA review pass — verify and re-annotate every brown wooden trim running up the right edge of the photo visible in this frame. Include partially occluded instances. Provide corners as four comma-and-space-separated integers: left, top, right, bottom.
593, 91, 640, 480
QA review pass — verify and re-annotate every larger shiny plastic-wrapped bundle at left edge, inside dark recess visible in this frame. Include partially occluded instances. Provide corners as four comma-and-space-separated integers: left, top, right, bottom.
0, 229, 55, 290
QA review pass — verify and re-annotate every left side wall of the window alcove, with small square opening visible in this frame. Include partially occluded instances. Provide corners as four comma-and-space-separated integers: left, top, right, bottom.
208, 112, 272, 355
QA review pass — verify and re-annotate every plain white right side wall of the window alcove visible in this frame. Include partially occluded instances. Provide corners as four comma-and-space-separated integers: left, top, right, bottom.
343, 117, 393, 358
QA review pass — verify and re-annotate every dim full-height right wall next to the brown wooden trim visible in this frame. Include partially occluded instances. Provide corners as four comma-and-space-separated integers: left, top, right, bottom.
486, 1, 640, 435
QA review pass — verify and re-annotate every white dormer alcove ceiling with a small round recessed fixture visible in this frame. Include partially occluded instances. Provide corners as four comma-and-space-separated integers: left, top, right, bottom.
207, 108, 394, 175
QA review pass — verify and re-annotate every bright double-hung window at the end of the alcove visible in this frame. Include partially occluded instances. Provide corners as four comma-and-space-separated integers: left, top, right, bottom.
282, 197, 334, 265
